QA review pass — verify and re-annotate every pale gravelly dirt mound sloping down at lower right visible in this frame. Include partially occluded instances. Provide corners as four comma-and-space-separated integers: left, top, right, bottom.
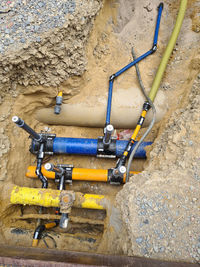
117, 75, 200, 262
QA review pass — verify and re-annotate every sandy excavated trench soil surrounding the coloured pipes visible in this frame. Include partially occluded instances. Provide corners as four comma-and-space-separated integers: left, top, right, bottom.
0, 0, 200, 262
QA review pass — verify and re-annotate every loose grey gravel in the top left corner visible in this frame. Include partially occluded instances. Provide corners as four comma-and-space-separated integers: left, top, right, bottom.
0, 0, 76, 54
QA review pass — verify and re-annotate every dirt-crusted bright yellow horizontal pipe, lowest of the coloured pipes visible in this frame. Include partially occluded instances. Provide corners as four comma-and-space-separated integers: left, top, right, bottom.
9, 185, 110, 210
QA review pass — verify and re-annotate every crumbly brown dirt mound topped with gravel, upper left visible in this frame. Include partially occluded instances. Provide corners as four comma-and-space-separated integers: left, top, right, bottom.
0, 0, 102, 95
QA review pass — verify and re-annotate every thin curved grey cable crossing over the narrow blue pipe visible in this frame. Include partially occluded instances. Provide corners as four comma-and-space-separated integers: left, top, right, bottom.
125, 48, 156, 183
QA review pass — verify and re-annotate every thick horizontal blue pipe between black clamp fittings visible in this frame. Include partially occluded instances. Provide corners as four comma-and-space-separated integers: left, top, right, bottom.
53, 137, 152, 158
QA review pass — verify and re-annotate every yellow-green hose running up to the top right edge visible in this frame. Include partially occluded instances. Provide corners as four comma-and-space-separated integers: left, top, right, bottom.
149, 0, 187, 102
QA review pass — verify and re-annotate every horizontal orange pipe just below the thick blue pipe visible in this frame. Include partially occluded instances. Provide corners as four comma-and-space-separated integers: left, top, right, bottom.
26, 166, 139, 182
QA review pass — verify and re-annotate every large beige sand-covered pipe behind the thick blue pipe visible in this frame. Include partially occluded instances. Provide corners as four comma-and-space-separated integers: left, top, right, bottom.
36, 88, 167, 129
